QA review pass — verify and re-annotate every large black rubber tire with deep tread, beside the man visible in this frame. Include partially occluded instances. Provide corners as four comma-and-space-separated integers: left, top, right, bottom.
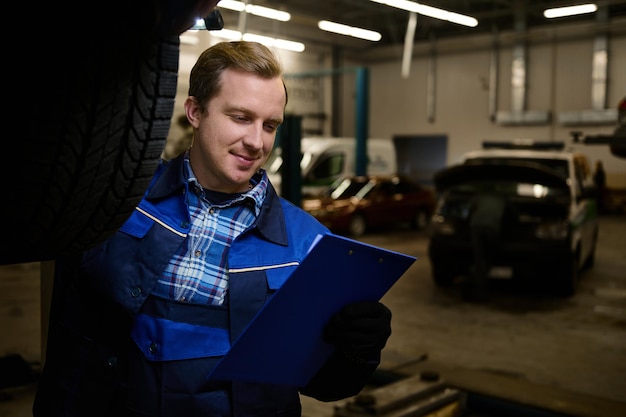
0, 0, 205, 264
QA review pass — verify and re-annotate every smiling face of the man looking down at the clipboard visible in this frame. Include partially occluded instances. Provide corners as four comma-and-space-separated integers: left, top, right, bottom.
185, 69, 286, 193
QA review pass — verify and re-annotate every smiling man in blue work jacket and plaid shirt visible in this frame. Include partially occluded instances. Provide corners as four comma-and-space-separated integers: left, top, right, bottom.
33, 42, 391, 417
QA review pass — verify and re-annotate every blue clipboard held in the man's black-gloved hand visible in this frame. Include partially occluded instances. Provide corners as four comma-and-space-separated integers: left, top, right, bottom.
208, 234, 417, 387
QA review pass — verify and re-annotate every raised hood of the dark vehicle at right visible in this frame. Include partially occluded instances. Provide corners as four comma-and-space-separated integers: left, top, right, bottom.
433, 161, 568, 191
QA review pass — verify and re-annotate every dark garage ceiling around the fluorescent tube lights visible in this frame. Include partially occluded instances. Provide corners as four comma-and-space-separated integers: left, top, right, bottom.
218, 0, 626, 52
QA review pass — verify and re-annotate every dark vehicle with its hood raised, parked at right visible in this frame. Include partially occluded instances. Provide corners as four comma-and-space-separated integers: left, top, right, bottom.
428, 140, 599, 296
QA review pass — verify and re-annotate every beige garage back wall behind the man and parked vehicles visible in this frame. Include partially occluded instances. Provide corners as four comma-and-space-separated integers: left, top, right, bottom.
170, 20, 626, 188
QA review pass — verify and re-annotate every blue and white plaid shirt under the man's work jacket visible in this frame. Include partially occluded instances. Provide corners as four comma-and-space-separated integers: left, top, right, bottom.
154, 155, 267, 305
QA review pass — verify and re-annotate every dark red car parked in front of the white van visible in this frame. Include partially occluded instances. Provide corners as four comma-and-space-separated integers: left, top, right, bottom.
302, 175, 435, 237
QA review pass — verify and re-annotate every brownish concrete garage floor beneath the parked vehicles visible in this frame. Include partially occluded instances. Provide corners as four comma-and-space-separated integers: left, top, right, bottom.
0, 216, 626, 417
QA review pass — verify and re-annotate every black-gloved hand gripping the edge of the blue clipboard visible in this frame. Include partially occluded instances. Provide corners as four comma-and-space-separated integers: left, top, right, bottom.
324, 301, 391, 362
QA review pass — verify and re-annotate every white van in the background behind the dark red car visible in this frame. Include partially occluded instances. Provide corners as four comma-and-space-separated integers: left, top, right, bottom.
265, 137, 397, 197
